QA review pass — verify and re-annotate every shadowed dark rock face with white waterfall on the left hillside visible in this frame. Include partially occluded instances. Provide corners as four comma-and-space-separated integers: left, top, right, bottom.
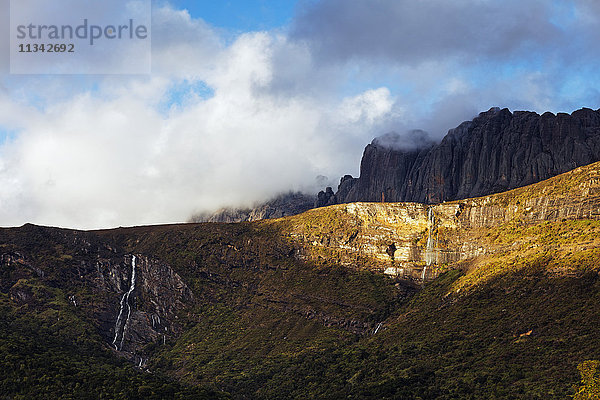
0, 225, 194, 367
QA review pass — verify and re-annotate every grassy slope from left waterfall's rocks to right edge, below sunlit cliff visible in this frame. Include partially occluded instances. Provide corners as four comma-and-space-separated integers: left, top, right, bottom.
108, 216, 600, 399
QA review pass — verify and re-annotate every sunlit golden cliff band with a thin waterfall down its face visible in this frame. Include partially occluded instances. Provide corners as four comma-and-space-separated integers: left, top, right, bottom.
285, 163, 600, 282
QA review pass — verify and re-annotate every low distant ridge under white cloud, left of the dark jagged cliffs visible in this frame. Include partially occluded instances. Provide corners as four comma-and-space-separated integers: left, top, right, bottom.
189, 192, 315, 223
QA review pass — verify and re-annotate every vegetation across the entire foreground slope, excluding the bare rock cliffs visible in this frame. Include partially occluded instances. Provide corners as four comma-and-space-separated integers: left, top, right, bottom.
0, 217, 600, 399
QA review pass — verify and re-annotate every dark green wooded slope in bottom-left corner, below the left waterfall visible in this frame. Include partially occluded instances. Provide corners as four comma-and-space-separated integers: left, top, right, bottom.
0, 281, 225, 399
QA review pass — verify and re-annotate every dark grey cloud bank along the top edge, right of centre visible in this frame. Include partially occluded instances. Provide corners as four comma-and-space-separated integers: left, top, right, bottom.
292, 0, 560, 65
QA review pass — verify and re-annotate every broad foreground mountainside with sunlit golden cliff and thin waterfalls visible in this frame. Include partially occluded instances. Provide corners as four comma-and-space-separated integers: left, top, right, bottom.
0, 163, 600, 399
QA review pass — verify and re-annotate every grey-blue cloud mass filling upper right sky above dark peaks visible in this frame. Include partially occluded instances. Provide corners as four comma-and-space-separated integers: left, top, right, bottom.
290, 0, 600, 131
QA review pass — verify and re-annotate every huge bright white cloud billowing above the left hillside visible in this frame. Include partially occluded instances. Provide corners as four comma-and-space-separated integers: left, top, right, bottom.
0, 9, 393, 228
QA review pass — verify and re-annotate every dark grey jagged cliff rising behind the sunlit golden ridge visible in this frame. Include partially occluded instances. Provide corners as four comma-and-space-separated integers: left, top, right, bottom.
326, 108, 600, 206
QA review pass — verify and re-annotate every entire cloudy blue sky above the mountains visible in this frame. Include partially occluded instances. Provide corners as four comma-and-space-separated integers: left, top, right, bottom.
0, 0, 600, 229
